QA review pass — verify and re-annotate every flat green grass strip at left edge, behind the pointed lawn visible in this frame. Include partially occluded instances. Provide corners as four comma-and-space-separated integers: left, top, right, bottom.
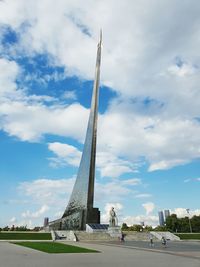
0, 232, 52, 240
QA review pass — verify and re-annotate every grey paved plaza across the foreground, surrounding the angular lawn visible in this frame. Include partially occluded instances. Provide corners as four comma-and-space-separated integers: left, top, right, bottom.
0, 241, 200, 267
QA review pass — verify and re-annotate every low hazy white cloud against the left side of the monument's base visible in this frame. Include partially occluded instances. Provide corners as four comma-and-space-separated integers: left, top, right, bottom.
17, 178, 75, 227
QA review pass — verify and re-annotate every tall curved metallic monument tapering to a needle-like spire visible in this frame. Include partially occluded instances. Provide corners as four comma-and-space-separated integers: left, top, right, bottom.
49, 32, 102, 230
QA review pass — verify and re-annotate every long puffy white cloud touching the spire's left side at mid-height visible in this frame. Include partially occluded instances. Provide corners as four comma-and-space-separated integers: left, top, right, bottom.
0, 101, 88, 141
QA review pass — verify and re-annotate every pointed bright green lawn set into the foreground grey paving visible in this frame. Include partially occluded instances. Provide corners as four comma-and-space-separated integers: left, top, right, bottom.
13, 242, 99, 253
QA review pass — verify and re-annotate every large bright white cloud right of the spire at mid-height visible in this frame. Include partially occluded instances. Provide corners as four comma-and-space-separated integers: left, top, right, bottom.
99, 107, 200, 171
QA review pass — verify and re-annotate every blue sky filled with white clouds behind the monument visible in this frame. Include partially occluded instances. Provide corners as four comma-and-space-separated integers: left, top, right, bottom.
0, 0, 200, 227
